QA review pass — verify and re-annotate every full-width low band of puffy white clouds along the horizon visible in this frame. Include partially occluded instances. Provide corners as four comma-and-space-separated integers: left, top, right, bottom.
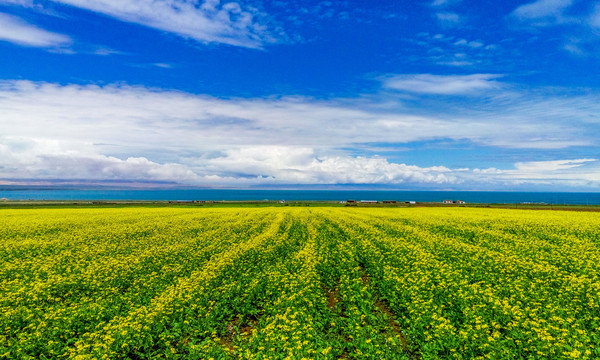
0, 137, 600, 189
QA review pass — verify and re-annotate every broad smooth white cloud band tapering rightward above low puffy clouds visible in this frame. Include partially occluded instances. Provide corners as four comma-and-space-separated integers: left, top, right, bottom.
0, 81, 464, 153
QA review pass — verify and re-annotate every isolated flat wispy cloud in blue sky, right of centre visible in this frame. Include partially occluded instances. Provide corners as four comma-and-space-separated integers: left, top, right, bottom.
384, 74, 501, 95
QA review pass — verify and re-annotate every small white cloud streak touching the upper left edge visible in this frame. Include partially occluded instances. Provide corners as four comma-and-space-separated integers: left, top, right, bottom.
0, 13, 71, 48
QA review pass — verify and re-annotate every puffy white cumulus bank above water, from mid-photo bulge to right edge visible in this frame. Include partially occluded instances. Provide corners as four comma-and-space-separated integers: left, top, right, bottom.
209, 155, 600, 189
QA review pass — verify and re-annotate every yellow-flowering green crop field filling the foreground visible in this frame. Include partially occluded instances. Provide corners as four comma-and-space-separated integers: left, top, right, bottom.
0, 206, 600, 359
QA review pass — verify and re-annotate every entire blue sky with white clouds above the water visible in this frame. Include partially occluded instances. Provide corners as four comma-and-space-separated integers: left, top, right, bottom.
0, 0, 600, 191
